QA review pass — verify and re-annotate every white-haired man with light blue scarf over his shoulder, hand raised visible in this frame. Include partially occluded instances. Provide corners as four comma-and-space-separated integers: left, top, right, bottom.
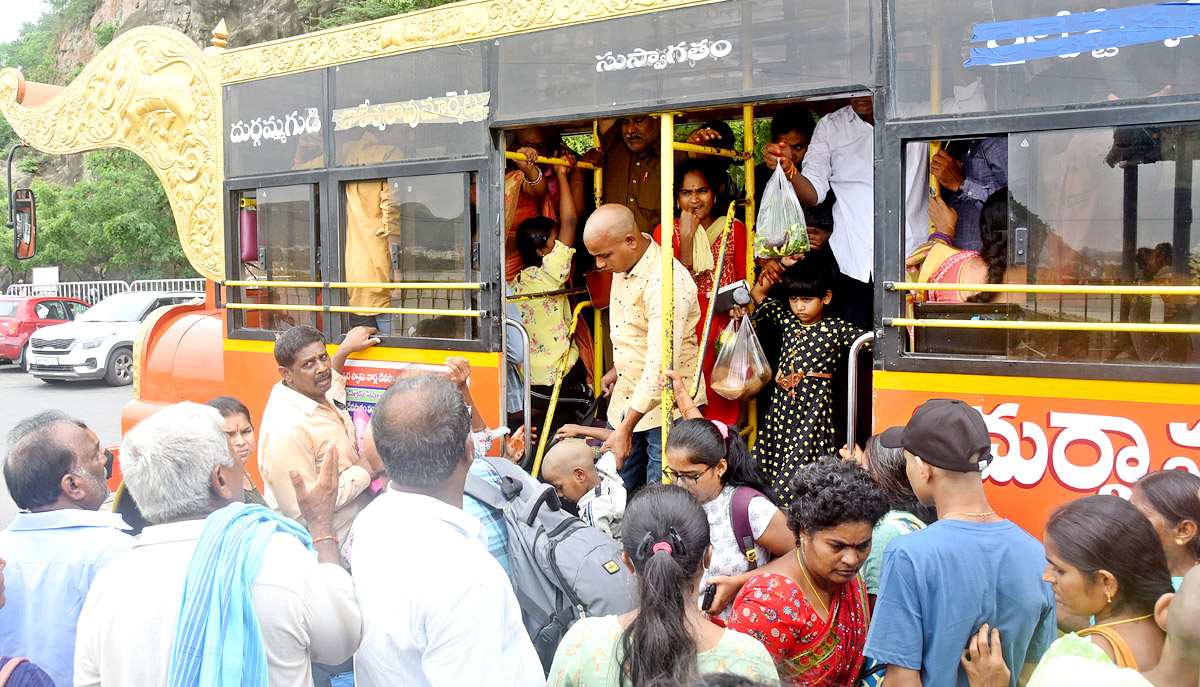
74, 404, 361, 687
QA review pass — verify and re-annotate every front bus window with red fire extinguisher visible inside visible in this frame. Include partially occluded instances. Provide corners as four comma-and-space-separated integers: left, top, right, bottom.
230, 184, 320, 330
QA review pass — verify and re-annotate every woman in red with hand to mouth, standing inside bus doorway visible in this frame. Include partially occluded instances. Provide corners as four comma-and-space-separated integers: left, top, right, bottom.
654, 159, 746, 425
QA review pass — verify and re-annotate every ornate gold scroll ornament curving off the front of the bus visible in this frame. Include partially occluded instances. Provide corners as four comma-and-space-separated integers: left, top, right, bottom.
0, 26, 224, 281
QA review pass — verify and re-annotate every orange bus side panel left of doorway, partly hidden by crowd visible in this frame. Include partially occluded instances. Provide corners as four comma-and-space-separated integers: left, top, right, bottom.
224, 339, 504, 489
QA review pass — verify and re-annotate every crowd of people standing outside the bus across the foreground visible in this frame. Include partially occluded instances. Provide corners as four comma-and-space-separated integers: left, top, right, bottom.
0, 324, 1200, 687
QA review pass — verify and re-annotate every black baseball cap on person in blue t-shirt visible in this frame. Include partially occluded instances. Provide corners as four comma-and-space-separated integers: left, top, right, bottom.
880, 399, 991, 472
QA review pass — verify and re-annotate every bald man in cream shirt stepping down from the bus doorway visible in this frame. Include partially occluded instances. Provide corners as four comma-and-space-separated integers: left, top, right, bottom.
583, 204, 706, 491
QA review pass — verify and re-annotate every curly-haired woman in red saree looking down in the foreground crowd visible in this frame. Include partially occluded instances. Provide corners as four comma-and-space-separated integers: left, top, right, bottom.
726, 458, 888, 687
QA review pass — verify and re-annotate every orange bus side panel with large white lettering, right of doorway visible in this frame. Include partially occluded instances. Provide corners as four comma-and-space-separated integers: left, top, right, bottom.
875, 372, 1200, 537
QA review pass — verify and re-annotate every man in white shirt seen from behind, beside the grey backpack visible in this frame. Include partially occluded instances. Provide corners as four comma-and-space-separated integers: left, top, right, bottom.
353, 375, 546, 687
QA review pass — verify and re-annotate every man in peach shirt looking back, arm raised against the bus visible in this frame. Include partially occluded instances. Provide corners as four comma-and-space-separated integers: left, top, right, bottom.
258, 324, 383, 542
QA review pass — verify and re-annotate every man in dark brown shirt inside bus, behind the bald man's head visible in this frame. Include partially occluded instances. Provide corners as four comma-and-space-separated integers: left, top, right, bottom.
582, 117, 661, 233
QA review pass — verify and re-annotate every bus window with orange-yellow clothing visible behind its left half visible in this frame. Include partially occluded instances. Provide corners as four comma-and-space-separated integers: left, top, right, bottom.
343, 173, 479, 340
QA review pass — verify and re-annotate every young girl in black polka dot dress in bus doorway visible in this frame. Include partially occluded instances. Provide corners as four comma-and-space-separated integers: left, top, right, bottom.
750, 251, 863, 507
